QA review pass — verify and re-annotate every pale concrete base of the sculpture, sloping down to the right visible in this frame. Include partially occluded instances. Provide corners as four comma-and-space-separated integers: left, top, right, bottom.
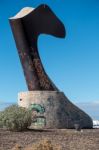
18, 91, 93, 129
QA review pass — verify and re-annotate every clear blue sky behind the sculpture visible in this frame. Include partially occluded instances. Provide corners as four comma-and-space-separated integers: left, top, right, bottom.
0, 0, 99, 103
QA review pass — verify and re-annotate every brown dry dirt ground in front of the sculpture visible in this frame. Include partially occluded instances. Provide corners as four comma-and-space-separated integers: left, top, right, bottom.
0, 129, 99, 150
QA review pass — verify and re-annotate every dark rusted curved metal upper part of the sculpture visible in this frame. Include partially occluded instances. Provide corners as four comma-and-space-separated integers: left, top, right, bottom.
10, 5, 66, 91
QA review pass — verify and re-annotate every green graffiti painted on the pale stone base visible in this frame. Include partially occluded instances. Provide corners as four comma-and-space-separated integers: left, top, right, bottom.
30, 104, 46, 128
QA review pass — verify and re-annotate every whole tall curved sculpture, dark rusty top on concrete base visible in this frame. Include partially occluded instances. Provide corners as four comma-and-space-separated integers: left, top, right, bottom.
10, 5, 93, 128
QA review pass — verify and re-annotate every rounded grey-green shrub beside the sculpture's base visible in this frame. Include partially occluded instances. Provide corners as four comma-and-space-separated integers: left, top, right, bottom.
0, 105, 31, 131
